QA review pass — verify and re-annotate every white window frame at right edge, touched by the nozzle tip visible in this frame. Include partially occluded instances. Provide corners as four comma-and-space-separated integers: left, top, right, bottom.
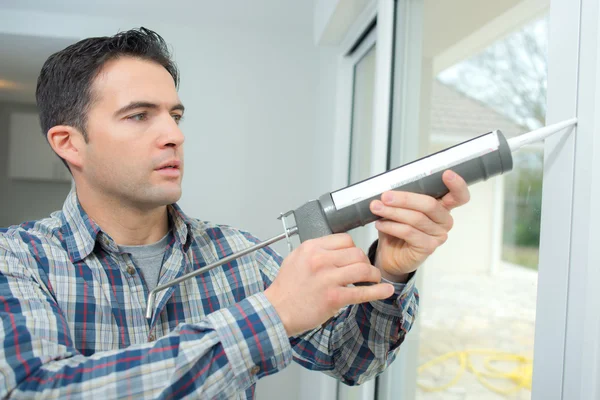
532, 0, 600, 400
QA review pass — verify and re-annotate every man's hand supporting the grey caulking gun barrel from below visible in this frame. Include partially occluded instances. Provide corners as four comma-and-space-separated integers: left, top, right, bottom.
371, 171, 470, 282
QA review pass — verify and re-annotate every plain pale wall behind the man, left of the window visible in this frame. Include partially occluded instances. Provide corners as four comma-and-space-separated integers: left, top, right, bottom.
0, 2, 336, 399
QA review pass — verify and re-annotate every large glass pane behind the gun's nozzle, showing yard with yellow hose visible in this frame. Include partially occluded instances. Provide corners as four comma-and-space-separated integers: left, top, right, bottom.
416, 9, 547, 400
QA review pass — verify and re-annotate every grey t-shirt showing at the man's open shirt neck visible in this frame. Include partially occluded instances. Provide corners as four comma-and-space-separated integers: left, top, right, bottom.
119, 233, 169, 292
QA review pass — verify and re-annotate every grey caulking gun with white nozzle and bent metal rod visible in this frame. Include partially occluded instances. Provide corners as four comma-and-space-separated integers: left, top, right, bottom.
146, 118, 577, 319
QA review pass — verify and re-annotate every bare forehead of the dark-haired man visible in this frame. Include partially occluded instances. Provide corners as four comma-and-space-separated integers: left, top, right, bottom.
92, 57, 180, 107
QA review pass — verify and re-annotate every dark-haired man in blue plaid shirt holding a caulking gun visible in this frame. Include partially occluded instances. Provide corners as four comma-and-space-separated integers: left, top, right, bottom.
0, 28, 469, 398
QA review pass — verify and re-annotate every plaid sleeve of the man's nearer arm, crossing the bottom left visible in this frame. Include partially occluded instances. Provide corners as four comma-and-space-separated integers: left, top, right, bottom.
0, 247, 292, 398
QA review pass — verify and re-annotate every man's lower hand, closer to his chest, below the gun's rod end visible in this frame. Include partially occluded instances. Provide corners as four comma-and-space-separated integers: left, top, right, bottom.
265, 233, 394, 336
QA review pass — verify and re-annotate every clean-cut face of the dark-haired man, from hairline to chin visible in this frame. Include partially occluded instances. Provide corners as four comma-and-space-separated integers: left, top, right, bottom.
78, 57, 184, 209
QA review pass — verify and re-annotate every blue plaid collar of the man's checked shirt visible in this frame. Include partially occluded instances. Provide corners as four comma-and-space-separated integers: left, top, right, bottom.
63, 189, 193, 262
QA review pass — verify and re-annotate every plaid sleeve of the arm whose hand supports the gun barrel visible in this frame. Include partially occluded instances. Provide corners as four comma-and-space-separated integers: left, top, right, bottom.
256, 242, 419, 386
